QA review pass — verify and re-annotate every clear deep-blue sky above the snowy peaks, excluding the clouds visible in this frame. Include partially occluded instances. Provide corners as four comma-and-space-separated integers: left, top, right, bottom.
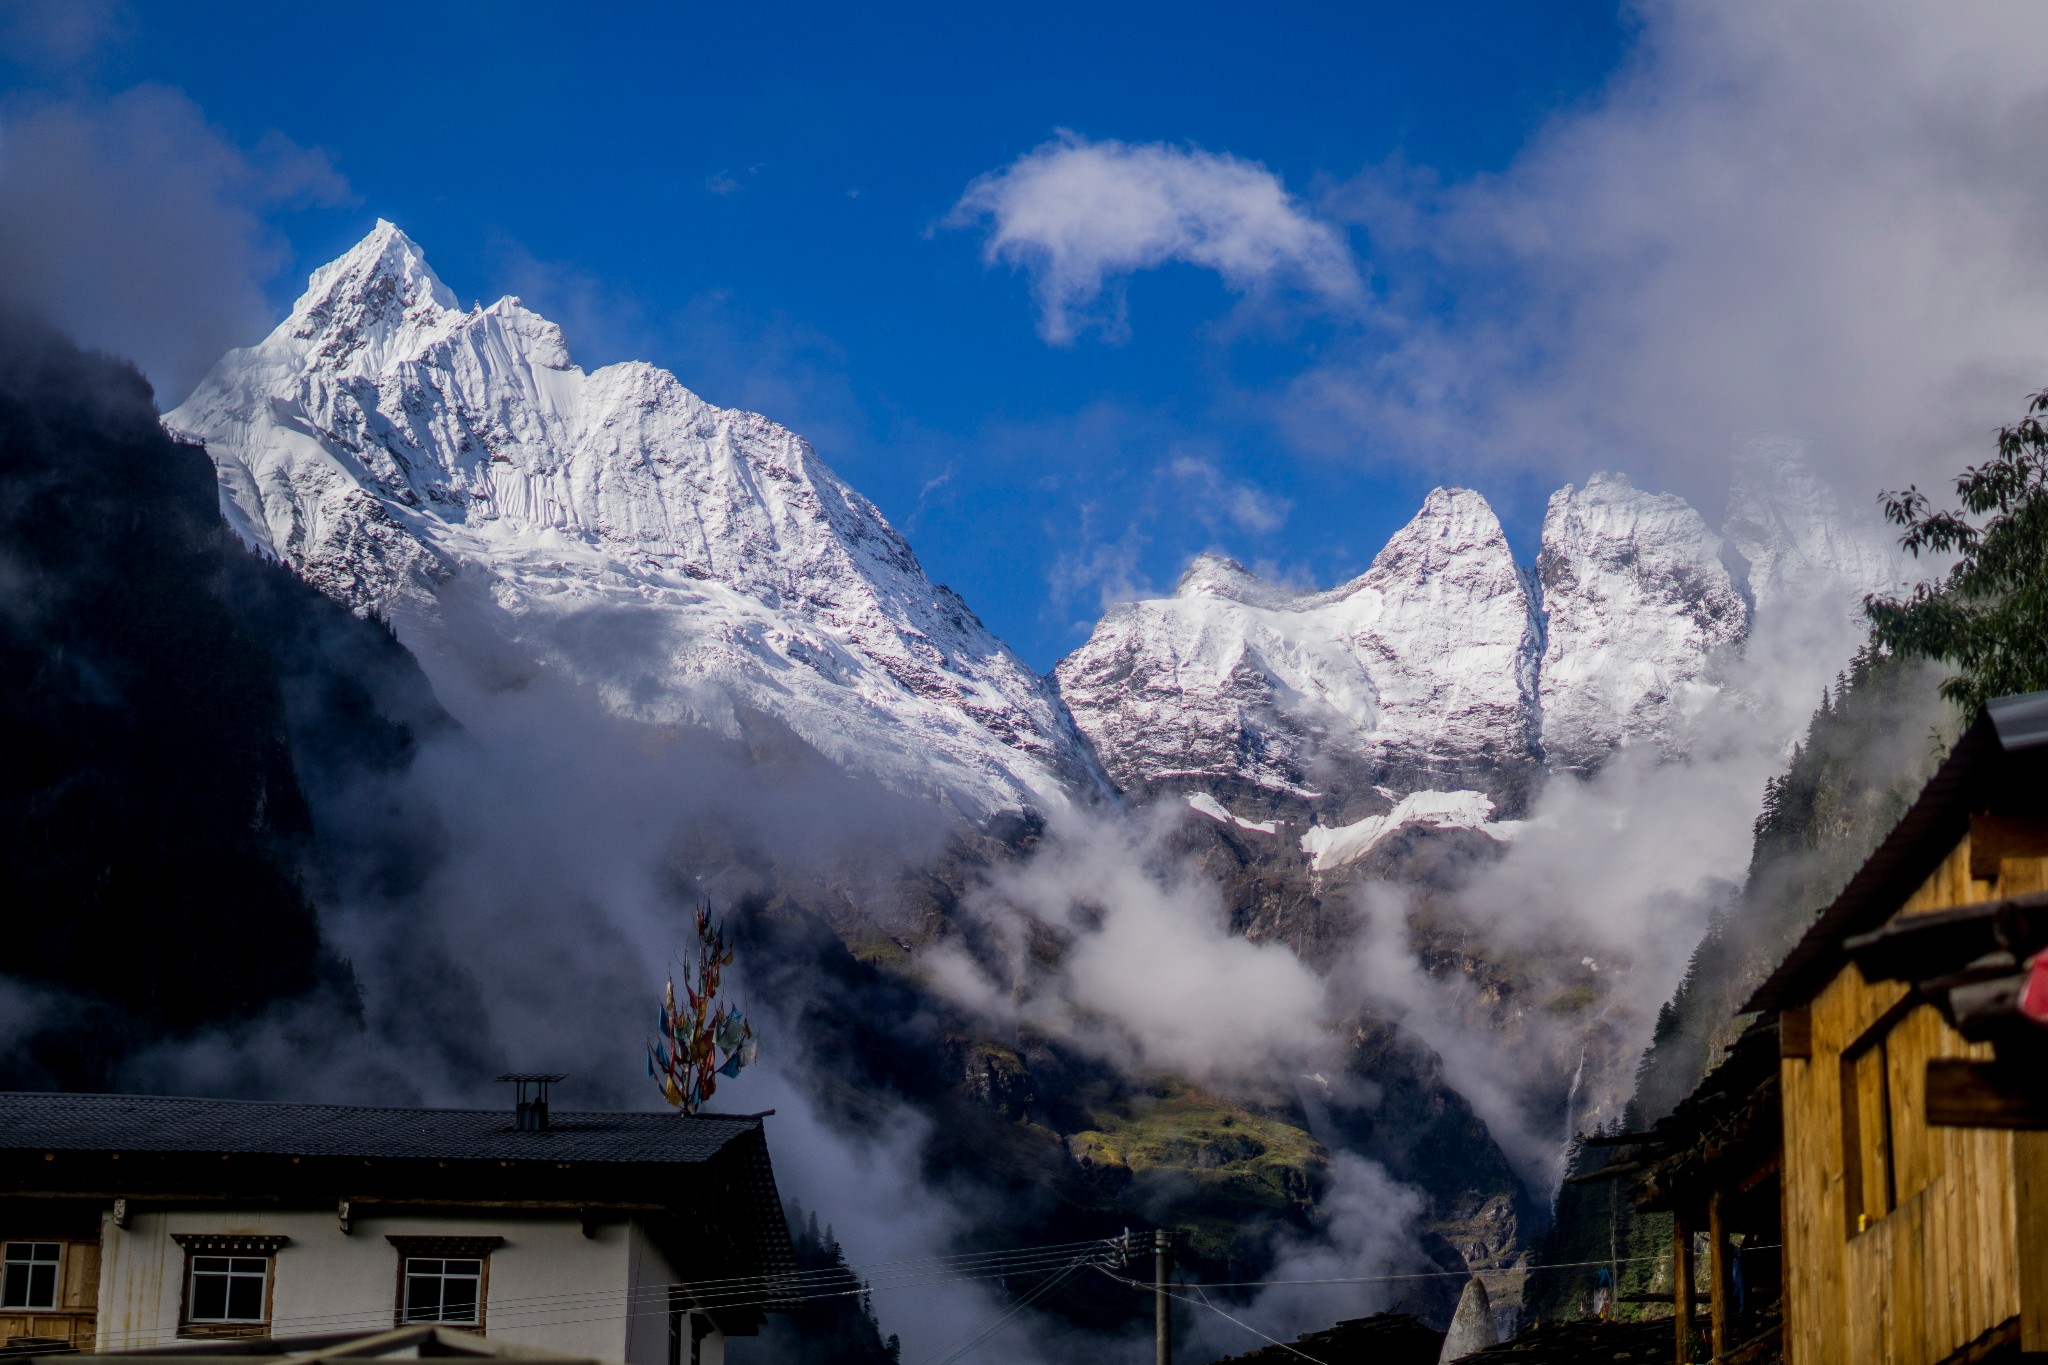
0, 0, 1622, 667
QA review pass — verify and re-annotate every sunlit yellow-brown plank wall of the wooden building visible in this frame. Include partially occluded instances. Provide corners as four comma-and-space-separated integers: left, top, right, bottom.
1780, 839, 2048, 1365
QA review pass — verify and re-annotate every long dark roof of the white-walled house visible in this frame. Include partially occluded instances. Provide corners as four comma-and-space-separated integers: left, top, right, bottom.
0, 1091, 760, 1162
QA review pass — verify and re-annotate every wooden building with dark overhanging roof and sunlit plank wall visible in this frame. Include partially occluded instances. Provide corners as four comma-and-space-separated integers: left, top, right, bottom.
1622, 694, 2048, 1365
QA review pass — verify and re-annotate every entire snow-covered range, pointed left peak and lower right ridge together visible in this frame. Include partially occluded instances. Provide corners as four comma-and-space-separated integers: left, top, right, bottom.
166, 223, 1896, 843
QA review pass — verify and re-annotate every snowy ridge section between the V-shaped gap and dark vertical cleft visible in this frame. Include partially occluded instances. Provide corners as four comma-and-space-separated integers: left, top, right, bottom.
1055, 489, 1538, 818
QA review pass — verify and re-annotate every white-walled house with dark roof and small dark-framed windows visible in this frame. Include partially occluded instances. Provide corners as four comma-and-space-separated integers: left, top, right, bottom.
0, 1076, 795, 1365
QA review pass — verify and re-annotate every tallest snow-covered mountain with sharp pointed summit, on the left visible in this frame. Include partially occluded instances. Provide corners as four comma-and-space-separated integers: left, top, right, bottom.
166, 221, 1106, 817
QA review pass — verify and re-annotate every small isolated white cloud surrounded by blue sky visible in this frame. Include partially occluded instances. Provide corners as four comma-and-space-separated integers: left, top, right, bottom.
948, 133, 1362, 346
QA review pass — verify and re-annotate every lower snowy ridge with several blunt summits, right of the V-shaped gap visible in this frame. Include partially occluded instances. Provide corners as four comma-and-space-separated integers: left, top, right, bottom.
1055, 458, 1901, 855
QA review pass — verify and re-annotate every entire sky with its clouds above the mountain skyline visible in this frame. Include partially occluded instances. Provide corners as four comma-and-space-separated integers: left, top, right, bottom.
0, 0, 2048, 667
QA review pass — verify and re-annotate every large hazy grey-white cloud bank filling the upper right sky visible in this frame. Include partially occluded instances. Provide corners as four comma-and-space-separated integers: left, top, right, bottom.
1278, 0, 2048, 507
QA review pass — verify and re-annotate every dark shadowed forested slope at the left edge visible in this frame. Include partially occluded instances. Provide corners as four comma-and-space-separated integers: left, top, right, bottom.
0, 317, 438, 1087
